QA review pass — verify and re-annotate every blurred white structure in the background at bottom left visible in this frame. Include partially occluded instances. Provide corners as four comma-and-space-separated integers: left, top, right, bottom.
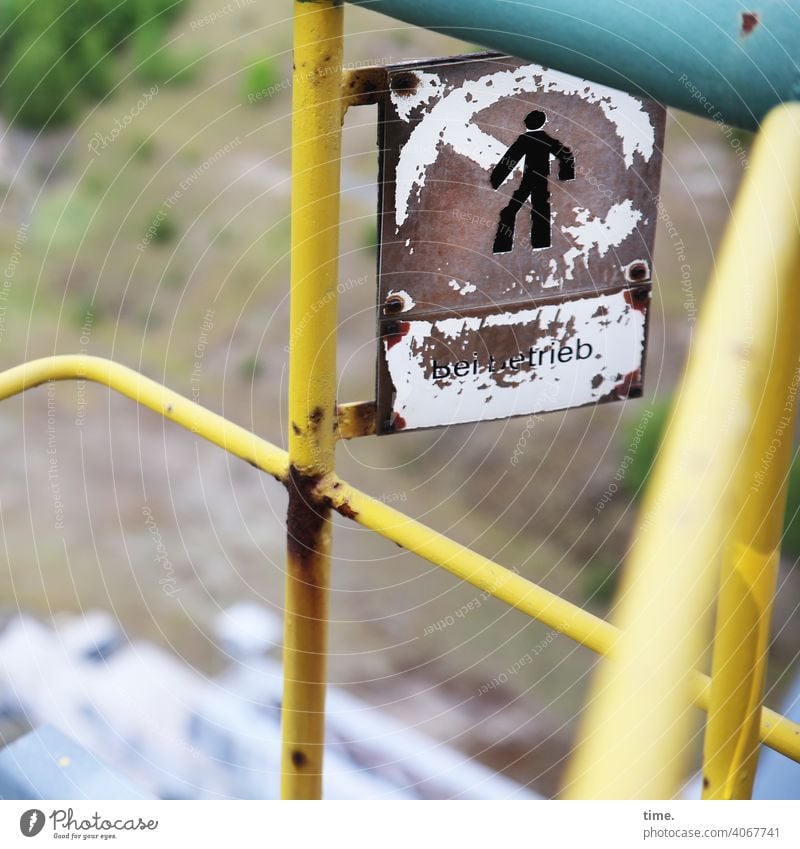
0, 604, 536, 799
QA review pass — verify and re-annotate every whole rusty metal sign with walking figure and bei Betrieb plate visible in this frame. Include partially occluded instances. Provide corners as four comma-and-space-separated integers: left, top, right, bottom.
377, 54, 665, 434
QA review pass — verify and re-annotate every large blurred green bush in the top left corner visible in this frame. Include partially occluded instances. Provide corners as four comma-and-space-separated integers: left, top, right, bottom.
0, 0, 190, 129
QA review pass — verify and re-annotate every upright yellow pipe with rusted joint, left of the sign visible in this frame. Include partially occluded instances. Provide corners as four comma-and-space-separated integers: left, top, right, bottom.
281, 0, 343, 799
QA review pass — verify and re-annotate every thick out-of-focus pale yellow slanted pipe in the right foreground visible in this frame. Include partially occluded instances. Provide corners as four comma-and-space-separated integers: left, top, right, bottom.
565, 104, 800, 799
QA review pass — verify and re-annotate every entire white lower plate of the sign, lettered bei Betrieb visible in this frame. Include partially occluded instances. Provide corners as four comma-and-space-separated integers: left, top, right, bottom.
381, 289, 649, 431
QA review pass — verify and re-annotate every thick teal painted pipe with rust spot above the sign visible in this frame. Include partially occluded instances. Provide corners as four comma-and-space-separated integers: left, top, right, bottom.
350, 0, 800, 130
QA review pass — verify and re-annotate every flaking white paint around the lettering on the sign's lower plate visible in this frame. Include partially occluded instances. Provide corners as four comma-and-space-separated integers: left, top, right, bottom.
384, 292, 645, 429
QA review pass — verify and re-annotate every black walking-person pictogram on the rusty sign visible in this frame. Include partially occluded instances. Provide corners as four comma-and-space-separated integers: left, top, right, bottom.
489, 109, 575, 254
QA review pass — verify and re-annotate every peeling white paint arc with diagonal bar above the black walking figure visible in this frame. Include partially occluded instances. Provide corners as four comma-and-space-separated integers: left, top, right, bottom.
392, 65, 655, 231
